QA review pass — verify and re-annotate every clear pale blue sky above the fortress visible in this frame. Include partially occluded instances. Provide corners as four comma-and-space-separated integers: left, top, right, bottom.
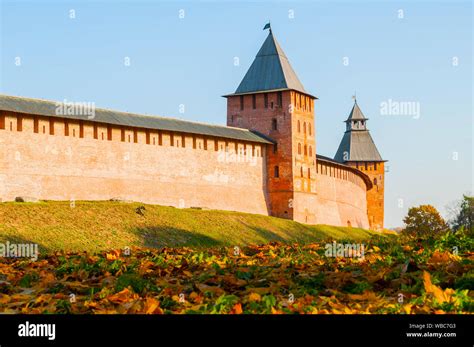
0, 0, 473, 227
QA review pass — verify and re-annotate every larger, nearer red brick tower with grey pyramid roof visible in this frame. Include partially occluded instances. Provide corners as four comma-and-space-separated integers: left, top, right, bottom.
225, 29, 316, 223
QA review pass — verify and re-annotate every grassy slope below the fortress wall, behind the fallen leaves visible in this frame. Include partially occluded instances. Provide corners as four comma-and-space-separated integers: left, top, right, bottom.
0, 201, 375, 252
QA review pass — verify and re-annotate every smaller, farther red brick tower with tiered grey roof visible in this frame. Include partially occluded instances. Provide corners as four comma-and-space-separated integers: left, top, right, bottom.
334, 100, 386, 230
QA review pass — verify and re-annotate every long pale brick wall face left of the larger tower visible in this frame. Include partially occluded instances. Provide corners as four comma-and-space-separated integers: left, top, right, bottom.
0, 111, 268, 214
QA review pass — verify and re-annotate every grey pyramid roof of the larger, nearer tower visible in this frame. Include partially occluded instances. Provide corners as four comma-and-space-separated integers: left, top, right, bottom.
230, 31, 309, 95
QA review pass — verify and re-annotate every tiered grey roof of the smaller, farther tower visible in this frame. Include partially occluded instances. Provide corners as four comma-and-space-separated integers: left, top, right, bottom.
334, 102, 385, 163
